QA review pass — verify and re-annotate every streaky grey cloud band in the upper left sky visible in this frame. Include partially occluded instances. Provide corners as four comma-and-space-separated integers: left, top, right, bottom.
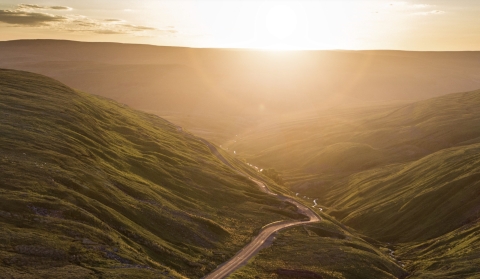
0, 4, 177, 36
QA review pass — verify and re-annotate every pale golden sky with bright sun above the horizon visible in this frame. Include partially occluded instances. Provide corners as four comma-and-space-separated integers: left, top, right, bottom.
0, 0, 480, 51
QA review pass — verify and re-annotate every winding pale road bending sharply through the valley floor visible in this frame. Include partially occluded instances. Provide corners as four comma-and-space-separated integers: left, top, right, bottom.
200, 139, 320, 279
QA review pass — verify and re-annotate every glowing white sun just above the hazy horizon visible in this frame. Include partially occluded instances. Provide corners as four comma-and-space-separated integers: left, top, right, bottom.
265, 4, 297, 40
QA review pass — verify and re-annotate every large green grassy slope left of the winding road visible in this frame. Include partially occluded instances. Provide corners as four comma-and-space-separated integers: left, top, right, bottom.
0, 70, 304, 278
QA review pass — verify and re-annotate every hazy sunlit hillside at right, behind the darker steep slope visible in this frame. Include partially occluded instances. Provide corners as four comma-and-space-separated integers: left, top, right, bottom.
227, 88, 480, 176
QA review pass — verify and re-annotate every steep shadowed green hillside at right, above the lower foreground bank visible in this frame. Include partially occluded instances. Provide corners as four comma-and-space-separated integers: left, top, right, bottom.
320, 144, 480, 242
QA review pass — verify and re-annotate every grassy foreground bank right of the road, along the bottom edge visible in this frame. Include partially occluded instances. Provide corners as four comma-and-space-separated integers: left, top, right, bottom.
231, 211, 480, 279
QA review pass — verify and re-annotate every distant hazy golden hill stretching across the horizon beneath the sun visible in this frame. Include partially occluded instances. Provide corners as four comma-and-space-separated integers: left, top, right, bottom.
0, 40, 480, 144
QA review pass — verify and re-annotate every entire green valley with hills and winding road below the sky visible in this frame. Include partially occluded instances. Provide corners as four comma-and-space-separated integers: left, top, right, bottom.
0, 40, 480, 279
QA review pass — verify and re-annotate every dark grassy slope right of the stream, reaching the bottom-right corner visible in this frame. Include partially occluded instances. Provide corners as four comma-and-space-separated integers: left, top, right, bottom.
312, 144, 480, 278
